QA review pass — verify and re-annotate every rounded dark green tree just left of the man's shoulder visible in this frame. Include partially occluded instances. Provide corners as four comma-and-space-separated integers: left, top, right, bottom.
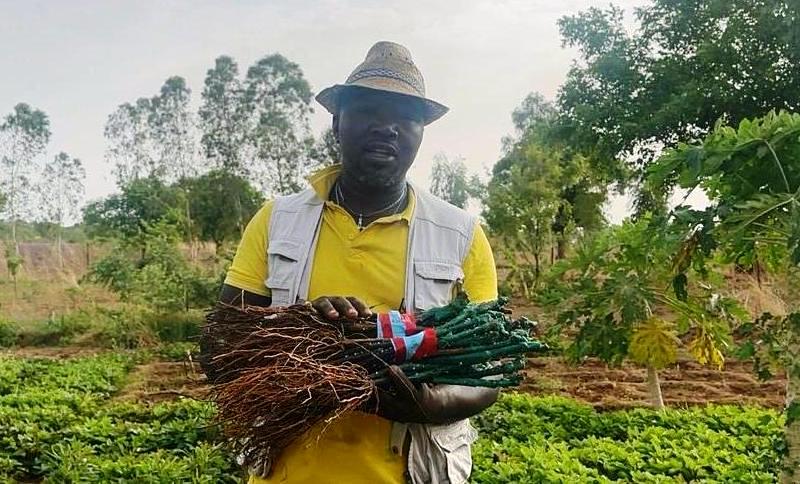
182, 170, 264, 252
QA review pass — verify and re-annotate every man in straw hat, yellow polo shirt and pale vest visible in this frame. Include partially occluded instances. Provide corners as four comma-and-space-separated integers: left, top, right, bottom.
221, 42, 497, 484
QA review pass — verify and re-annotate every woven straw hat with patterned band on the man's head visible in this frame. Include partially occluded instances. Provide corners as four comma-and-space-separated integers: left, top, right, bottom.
316, 41, 449, 124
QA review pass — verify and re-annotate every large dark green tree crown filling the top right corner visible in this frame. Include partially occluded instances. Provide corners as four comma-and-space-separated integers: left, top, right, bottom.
558, 0, 800, 199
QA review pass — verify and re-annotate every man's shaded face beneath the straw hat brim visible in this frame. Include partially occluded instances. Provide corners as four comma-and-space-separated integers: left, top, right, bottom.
333, 89, 425, 188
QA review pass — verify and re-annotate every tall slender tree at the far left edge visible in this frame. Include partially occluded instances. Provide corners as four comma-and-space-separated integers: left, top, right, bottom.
0, 103, 50, 251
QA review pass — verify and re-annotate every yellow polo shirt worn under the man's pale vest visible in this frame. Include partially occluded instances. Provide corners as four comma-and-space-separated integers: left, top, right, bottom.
225, 165, 497, 484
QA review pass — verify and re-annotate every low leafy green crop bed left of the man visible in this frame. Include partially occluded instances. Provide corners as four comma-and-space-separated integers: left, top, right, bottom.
0, 355, 240, 483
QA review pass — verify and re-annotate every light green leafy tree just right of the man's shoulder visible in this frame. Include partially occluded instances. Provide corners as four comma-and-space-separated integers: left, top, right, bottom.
483, 93, 608, 297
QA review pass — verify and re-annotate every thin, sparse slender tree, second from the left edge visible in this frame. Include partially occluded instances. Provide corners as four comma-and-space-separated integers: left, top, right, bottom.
40, 151, 86, 269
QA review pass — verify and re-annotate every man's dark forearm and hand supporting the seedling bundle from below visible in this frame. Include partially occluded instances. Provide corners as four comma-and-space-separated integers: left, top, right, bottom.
376, 366, 499, 424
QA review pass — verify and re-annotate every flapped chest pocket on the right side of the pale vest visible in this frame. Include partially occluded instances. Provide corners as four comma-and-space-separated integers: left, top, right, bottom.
414, 261, 464, 312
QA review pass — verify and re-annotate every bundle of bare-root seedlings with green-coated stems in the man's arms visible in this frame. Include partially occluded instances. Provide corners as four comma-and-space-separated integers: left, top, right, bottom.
201, 296, 545, 465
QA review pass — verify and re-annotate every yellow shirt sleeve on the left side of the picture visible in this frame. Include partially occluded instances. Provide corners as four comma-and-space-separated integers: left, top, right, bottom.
225, 201, 274, 296
